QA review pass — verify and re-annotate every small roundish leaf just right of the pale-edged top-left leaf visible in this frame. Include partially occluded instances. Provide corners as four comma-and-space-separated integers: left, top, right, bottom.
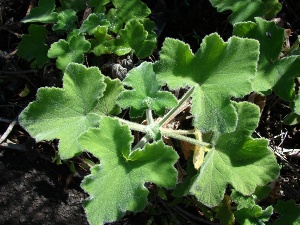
52, 9, 77, 31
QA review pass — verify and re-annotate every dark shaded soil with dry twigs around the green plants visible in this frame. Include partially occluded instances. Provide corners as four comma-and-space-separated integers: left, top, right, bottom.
0, 0, 300, 225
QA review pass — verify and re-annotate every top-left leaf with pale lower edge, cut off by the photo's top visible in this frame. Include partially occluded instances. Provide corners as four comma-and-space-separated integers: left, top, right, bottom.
21, 0, 57, 23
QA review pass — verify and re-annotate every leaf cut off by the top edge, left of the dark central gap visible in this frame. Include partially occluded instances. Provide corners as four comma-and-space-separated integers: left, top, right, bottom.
107, 0, 151, 33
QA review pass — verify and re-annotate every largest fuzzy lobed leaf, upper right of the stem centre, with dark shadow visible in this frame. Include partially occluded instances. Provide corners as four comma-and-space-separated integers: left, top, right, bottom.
154, 34, 259, 132
